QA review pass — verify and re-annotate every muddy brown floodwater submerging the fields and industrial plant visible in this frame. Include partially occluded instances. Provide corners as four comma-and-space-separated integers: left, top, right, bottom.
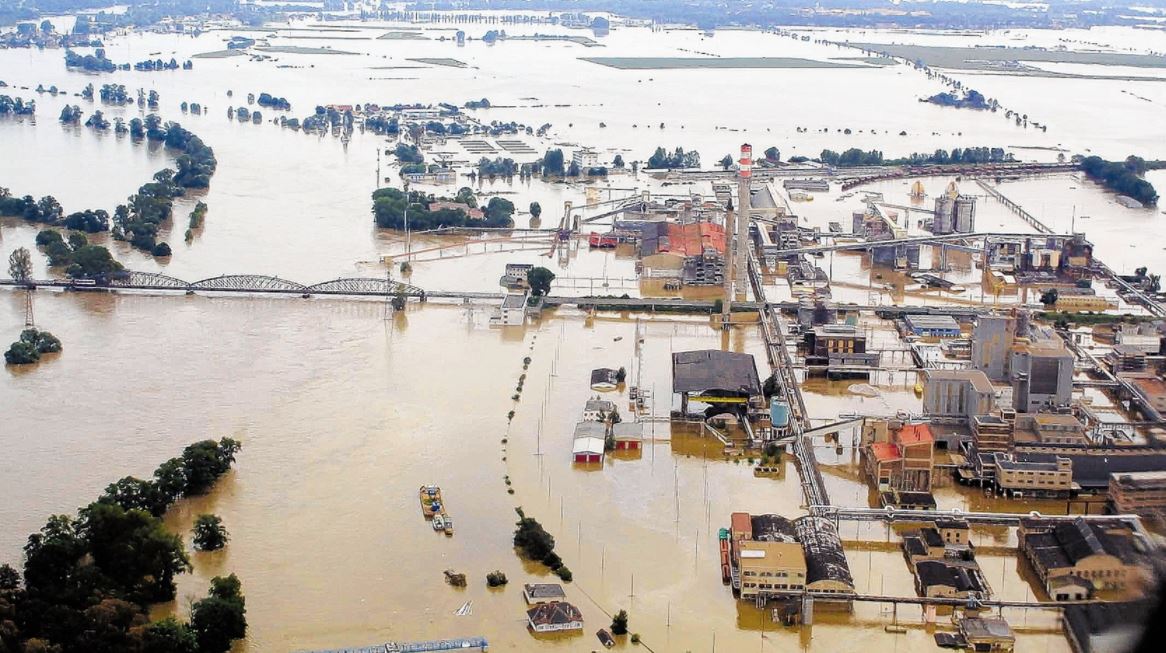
0, 15, 1166, 652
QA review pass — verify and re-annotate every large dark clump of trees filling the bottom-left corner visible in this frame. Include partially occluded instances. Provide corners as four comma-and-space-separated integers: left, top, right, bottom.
0, 437, 246, 653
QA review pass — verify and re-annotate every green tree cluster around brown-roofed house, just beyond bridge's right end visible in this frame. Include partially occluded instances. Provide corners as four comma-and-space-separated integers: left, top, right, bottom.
372, 188, 514, 230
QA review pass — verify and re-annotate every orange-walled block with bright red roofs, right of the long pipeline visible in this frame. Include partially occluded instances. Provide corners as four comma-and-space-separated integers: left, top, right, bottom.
862, 420, 935, 492
